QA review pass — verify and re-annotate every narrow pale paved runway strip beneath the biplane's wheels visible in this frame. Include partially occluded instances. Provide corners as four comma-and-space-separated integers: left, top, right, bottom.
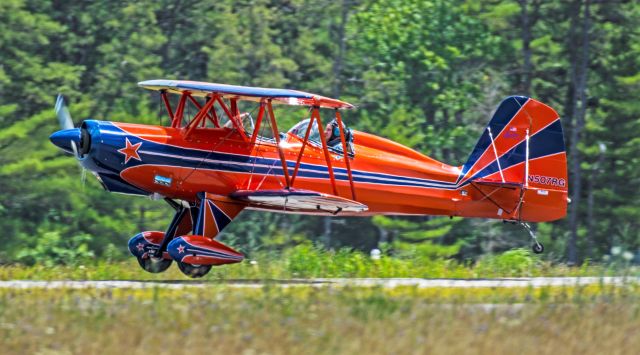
0, 277, 640, 289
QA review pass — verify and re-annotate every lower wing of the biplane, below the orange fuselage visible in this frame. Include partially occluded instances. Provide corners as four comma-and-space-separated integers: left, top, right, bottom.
230, 189, 369, 214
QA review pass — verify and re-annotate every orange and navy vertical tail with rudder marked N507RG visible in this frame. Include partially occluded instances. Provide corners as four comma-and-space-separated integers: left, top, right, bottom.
458, 96, 568, 221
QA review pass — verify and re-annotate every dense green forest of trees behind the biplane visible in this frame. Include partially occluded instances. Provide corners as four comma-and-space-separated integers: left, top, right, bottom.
0, 0, 640, 264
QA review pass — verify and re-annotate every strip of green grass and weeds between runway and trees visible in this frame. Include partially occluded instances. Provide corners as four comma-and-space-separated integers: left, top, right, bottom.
0, 245, 640, 280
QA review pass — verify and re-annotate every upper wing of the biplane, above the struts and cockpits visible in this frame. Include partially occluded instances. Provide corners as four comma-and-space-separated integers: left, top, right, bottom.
138, 80, 354, 109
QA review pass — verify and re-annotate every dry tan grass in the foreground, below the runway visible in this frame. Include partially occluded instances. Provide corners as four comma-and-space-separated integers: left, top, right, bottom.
0, 285, 640, 354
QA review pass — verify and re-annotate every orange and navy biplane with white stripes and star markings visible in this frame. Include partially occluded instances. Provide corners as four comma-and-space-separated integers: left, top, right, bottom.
50, 80, 567, 277
